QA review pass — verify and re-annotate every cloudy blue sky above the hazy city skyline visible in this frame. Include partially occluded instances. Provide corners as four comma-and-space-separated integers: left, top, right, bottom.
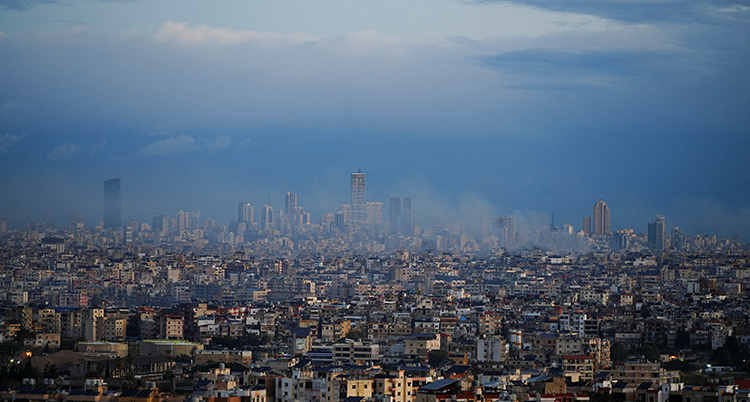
0, 0, 750, 241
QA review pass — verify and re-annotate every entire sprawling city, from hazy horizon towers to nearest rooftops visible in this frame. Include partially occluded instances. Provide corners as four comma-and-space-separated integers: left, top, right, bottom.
0, 171, 750, 402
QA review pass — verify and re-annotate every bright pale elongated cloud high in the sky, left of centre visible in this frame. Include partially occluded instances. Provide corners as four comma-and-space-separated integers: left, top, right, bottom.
153, 21, 320, 45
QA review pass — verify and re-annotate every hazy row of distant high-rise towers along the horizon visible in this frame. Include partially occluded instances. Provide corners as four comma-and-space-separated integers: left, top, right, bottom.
0, 169, 742, 245
